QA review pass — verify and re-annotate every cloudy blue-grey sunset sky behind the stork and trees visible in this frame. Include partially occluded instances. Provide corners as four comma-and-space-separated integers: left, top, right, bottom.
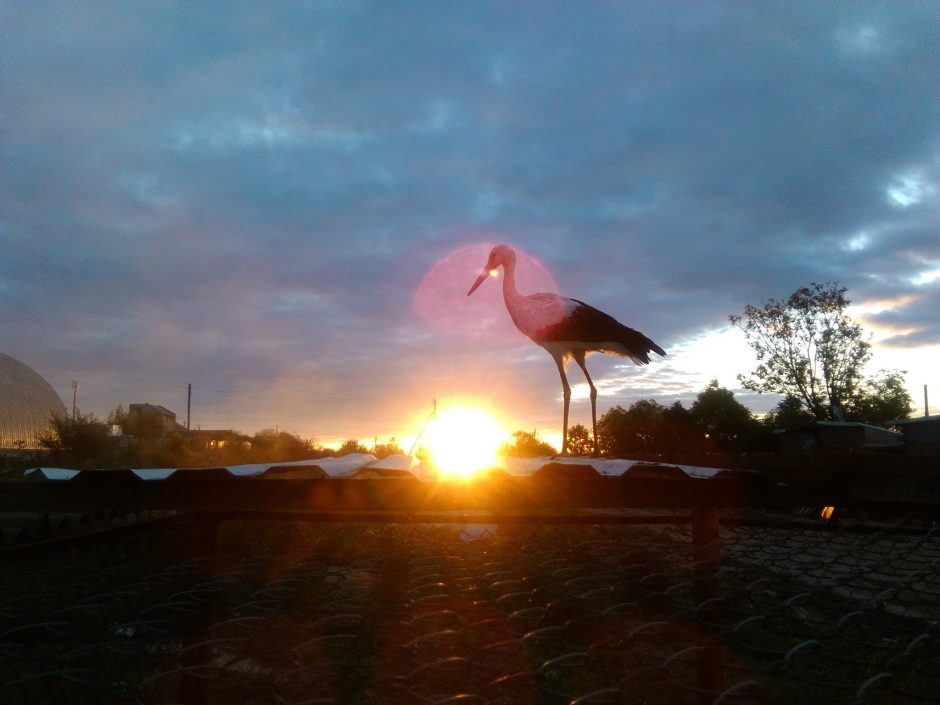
0, 0, 940, 441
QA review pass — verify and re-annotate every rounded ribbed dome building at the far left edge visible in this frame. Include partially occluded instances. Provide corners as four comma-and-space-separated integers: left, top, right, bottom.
0, 353, 65, 450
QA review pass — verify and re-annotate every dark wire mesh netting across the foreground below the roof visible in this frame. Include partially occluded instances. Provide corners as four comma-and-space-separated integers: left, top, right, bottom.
0, 521, 940, 705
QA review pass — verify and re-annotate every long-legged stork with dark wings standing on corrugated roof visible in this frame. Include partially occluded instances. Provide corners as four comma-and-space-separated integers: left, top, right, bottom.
467, 245, 666, 455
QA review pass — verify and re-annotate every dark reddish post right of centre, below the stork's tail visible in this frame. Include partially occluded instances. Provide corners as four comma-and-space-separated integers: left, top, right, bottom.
692, 507, 725, 703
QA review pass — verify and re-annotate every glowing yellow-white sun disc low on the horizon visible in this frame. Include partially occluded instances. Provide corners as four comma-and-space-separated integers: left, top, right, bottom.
428, 406, 508, 479
